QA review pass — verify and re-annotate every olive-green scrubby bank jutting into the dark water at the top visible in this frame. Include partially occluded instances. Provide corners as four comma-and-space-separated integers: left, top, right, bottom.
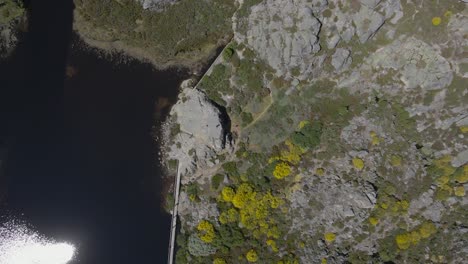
75, 0, 235, 65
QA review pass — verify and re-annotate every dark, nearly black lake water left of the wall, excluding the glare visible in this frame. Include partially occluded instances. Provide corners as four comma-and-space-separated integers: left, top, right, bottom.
0, 0, 187, 264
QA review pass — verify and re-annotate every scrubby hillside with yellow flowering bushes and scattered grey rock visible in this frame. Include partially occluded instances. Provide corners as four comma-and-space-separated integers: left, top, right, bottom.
173, 0, 468, 264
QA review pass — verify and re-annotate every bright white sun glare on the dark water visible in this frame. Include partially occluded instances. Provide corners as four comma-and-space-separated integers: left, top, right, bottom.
0, 222, 75, 264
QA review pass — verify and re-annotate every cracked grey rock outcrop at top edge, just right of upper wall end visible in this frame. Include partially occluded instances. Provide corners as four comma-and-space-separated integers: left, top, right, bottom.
236, 0, 326, 76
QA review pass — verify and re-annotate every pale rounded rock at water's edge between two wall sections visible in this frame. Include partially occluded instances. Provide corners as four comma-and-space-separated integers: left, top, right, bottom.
166, 85, 231, 177
